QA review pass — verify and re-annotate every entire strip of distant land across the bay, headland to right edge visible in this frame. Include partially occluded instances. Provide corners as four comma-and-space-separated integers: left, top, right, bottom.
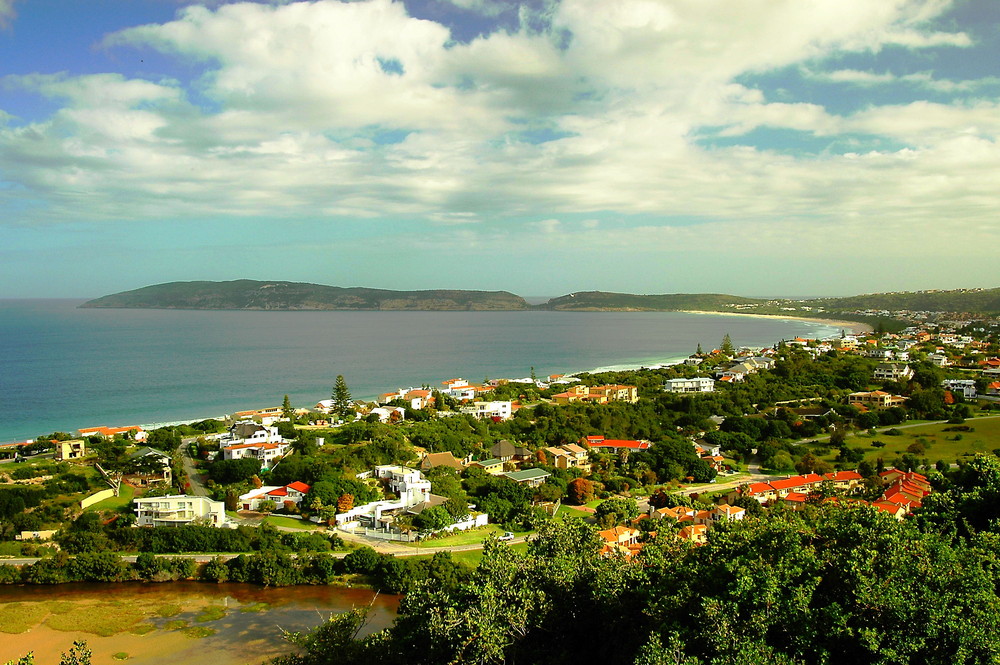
80, 279, 1000, 329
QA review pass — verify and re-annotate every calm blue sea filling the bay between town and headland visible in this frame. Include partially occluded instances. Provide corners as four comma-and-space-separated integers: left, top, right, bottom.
0, 300, 840, 442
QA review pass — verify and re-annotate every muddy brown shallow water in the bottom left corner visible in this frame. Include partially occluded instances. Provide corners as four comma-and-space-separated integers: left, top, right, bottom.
0, 582, 400, 665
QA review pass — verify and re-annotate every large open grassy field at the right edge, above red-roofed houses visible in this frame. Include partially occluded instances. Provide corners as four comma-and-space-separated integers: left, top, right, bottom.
825, 418, 1000, 464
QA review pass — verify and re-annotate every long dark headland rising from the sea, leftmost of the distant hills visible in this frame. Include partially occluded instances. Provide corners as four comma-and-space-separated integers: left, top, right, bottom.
80, 279, 528, 311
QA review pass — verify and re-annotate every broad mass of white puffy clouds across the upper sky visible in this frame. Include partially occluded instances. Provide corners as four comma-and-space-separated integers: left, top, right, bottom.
0, 0, 1000, 262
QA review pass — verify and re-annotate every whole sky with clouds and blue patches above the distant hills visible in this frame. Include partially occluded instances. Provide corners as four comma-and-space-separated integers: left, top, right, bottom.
0, 0, 1000, 298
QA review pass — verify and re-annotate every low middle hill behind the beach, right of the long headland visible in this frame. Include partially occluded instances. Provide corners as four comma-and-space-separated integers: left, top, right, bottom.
535, 291, 766, 312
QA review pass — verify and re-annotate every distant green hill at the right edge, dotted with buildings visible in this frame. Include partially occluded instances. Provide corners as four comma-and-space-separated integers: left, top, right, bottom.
808, 289, 1000, 314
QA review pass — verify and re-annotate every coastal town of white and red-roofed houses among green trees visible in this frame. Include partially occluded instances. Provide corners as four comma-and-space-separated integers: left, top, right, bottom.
0, 321, 1000, 662
